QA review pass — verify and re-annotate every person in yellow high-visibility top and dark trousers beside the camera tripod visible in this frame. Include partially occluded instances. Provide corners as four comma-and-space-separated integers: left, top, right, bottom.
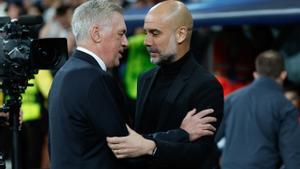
21, 70, 53, 169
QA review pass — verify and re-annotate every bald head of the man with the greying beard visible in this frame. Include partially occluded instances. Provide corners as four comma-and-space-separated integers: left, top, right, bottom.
144, 0, 193, 65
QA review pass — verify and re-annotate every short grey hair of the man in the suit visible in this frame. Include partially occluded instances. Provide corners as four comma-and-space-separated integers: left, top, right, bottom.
72, 0, 123, 41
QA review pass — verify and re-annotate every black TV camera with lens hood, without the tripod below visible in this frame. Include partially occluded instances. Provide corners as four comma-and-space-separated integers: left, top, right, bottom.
0, 16, 68, 93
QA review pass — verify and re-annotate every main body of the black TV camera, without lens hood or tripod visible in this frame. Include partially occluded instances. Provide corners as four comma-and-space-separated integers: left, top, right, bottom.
0, 18, 37, 79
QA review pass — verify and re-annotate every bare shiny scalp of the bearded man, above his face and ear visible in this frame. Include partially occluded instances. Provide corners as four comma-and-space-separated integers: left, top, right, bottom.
147, 0, 193, 29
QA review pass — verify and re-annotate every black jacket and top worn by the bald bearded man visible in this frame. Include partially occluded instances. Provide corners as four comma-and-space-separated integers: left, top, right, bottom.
134, 52, 223, 169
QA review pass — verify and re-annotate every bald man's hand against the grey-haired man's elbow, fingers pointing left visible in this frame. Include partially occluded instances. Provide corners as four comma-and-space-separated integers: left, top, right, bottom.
106, 126, 156, 158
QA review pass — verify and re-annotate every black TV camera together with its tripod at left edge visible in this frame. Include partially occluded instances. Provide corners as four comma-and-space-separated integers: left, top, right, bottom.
0, 16, 68, 169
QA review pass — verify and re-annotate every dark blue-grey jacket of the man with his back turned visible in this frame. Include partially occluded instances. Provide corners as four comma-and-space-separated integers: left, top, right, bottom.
218, 77, 300, 169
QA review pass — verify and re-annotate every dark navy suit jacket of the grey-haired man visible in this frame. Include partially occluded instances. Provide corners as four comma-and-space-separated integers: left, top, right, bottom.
49, 51, 128, 169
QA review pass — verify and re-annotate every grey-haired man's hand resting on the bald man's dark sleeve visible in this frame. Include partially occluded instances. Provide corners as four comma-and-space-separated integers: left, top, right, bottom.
180, 109, 217, 141
